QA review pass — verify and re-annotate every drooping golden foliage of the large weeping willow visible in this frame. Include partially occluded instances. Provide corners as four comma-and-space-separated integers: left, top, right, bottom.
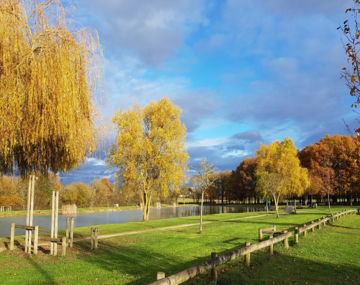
0, 0, 102, 175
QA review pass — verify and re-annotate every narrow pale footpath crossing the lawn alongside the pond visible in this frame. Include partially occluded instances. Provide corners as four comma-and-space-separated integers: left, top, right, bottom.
0, 214, 272, 252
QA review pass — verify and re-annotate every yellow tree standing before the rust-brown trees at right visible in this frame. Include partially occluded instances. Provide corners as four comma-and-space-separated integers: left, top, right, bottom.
255, 138, 310, 217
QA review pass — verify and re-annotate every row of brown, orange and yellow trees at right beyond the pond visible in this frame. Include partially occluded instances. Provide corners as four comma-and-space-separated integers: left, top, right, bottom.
192, 135, 360, 209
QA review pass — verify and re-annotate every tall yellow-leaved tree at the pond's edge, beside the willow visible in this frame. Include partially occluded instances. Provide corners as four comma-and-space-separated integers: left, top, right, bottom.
107, 98, 188, 221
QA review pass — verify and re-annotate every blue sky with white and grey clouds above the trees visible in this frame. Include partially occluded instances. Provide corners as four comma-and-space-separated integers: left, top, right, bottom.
60, 0, 358, 184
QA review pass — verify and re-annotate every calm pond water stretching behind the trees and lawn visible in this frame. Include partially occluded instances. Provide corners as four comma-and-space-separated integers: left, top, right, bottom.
0, 203, 255, 237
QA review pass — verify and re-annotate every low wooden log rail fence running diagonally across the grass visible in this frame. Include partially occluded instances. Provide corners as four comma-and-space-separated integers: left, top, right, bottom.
149, 207, 357, 285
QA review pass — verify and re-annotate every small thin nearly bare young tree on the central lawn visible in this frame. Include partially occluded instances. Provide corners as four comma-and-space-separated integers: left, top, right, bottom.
191, 159, 216, 233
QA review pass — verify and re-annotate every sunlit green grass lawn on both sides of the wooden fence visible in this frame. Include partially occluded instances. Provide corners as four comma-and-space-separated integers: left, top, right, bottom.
0, 208, 360, 284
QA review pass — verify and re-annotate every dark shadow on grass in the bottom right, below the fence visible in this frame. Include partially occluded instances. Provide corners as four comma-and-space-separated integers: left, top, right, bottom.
184, 247, 360, 285
